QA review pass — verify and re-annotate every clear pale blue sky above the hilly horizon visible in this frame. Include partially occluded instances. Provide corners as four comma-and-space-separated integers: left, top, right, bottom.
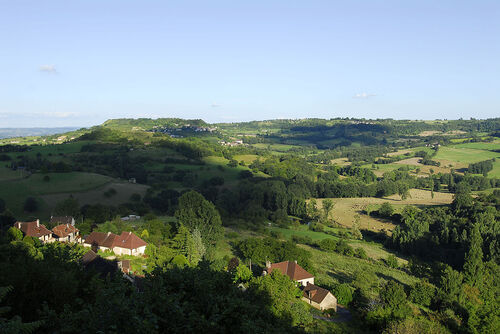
0, 0, 500, 128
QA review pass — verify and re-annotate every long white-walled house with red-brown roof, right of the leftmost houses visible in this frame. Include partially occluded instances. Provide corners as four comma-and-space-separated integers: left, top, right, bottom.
83, 232, 147, 255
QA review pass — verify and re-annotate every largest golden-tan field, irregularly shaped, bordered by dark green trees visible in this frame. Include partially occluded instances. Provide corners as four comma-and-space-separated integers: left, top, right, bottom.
316, 189, 453, 232
